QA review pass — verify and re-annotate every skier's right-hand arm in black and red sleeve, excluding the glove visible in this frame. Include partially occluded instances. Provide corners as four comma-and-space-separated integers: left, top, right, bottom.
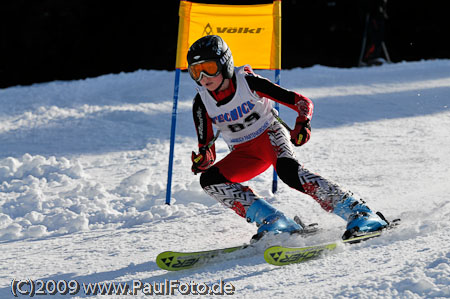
245, 73, 314, 122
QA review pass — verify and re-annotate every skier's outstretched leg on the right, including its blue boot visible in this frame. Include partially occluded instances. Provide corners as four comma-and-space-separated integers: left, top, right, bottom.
269, 122, 387, 234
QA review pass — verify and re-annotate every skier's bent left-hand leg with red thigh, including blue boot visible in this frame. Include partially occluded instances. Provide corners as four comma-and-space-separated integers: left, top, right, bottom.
200, 134, 301, 233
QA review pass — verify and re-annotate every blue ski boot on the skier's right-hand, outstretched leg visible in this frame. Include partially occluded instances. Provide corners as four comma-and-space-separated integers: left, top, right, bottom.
333, 195, 388, 240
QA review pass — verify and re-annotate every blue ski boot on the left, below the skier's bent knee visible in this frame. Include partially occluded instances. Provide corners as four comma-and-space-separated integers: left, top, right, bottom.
245, 198, 303, 241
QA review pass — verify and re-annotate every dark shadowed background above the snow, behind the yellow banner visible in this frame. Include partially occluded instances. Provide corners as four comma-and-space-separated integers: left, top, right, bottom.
0, 0, 450, 88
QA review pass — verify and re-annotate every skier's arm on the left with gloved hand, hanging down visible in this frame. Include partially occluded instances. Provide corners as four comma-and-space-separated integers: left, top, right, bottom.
191, 94, 216, 174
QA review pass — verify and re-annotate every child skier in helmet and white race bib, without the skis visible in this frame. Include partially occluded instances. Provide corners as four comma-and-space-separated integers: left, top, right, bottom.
187, 35, 387, 239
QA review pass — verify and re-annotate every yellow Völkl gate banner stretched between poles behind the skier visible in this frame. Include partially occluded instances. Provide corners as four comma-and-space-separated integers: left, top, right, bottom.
176, 0, 281, 69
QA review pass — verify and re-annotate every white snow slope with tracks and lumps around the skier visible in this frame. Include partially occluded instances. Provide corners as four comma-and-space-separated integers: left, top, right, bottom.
0, 60, 450, 298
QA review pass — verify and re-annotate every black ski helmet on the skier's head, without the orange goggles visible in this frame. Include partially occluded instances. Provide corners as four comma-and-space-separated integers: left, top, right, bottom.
187, 35, 234, 79
